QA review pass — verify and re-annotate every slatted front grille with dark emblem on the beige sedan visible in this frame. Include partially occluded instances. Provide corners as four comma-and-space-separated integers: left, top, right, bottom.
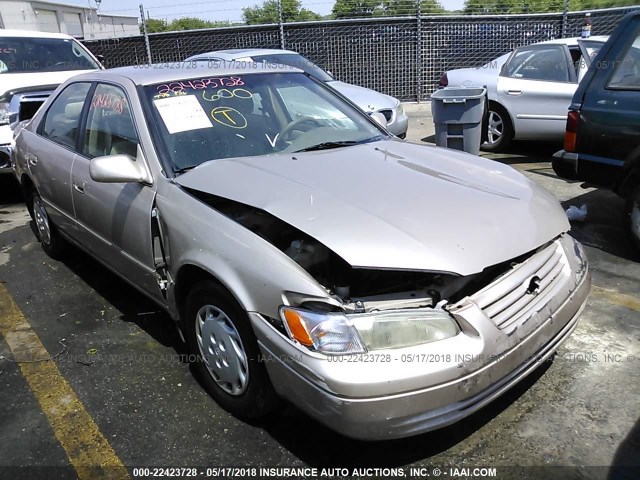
471, 241, 571, 330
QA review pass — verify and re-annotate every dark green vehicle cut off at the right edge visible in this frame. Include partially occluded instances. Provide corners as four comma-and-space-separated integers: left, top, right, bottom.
553, 12, 640, 249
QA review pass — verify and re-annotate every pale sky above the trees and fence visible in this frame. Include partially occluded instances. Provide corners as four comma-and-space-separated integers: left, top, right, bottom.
62, 0, 464, 22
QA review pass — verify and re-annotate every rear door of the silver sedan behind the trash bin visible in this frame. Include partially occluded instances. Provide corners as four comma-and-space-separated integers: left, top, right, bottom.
497, 44, 577, 140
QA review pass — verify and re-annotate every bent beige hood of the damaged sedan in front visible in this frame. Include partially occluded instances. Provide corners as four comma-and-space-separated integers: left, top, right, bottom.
176, 140, 569, 275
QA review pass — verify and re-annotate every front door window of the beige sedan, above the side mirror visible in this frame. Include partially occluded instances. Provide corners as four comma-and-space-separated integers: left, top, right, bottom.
82, 84, 138, 158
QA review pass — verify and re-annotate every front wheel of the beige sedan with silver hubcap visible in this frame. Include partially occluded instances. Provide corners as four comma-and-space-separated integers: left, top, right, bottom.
183, 281, 279, 418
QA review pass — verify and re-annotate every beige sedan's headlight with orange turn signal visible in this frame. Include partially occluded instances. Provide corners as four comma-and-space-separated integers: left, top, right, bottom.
280, 306, 460, 355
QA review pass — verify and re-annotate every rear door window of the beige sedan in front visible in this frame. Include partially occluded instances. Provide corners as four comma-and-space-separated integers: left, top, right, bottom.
39, 83, 91, 149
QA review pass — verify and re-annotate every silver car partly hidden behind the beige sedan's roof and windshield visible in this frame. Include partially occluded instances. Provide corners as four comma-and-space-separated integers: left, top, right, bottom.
185, 48, 409, 138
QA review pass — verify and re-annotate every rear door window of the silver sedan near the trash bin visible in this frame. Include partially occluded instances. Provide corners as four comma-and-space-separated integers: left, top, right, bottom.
504, 45, 569, 82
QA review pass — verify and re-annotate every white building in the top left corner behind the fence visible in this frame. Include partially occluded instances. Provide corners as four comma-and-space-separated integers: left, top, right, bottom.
0, 0, 140, 40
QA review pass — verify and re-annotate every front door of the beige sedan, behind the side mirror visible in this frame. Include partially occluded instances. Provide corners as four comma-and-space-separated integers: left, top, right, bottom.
71, 83, 161, 300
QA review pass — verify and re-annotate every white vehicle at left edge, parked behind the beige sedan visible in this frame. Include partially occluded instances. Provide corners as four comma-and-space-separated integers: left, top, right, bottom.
0, 29, 102, 175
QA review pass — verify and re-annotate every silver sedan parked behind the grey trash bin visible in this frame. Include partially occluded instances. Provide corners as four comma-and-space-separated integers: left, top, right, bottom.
439, 37, 607, 152
